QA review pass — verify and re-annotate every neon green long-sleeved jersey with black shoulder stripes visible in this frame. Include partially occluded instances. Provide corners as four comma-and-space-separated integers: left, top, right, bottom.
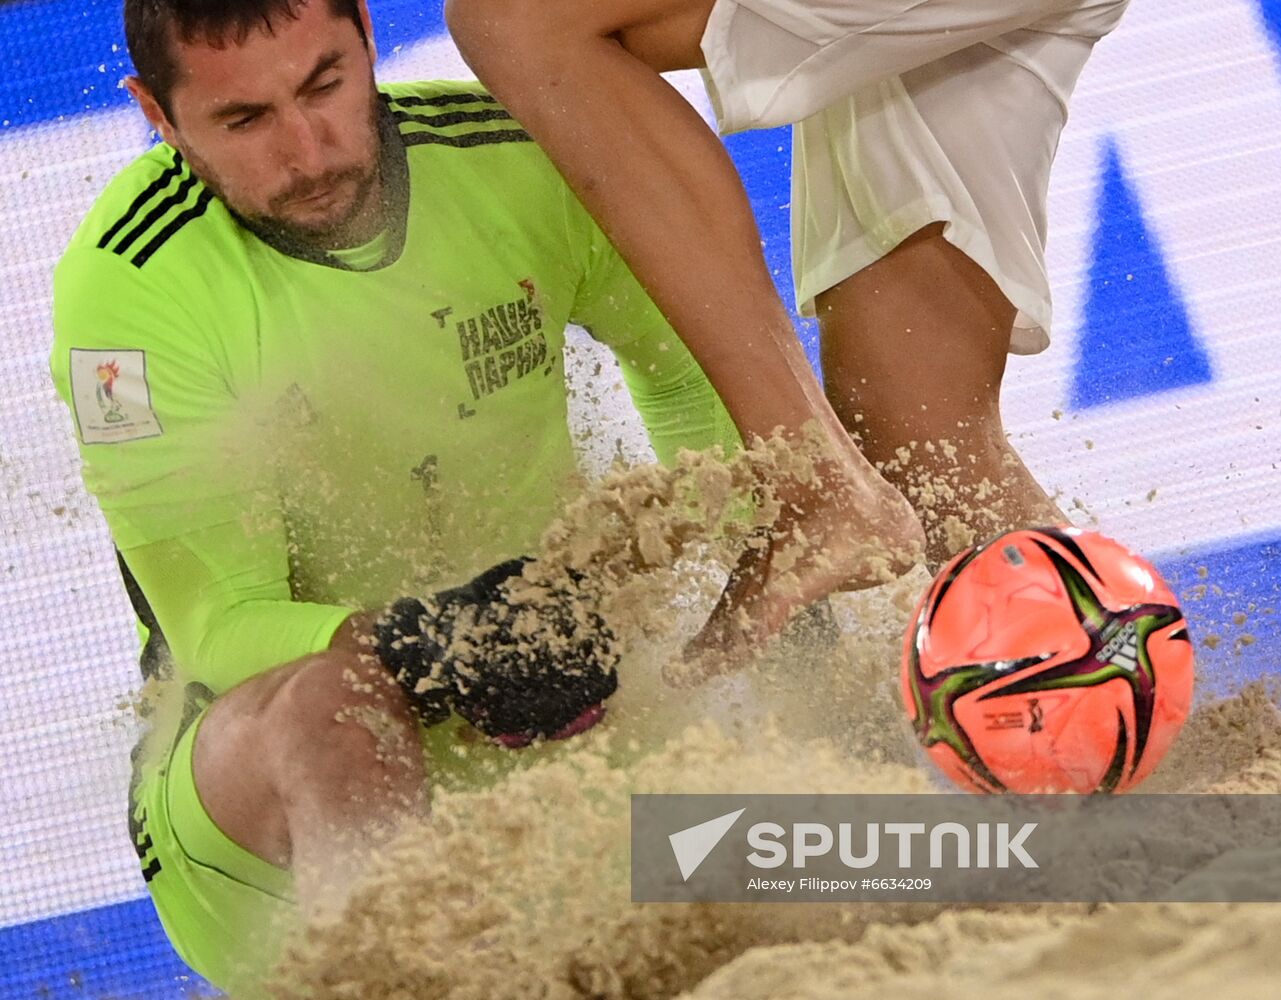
51, 83, 738, 693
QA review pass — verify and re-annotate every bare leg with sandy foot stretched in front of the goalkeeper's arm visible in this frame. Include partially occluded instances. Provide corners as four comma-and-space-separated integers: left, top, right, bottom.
446, 0, 922, 645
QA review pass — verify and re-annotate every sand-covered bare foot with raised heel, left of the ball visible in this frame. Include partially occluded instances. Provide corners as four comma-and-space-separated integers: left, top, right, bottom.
664, 466, 925, 686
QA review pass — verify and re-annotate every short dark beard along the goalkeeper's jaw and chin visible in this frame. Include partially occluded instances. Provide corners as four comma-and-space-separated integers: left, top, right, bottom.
183, 91, 384, 251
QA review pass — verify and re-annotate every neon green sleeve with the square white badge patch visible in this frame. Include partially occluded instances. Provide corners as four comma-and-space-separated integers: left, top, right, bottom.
50, 247, 351, 693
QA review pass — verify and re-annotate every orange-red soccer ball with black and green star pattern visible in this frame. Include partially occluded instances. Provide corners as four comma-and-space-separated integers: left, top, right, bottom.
902, 528, 1193, 793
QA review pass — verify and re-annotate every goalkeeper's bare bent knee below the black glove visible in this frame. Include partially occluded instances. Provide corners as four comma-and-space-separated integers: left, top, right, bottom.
193, 650, 425, 910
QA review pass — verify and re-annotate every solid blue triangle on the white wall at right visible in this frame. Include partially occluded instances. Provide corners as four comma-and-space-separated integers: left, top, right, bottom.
1072, 140, 1213, 408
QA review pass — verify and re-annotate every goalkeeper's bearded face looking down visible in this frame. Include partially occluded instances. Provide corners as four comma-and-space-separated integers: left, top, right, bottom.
140, 0, 382, 250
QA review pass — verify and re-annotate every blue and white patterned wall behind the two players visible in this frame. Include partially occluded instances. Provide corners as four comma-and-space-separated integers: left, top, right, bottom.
0, 0, 1281, 1000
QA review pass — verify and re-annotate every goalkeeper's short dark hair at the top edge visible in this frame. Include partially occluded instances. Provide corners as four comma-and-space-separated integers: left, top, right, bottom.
124, 0, 365, 119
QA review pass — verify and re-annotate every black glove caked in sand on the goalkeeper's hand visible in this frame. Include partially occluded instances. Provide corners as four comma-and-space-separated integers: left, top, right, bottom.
374, 560, 619, 746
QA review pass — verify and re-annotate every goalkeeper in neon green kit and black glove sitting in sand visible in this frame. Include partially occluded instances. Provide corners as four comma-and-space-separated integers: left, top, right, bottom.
51, 0, 738, 995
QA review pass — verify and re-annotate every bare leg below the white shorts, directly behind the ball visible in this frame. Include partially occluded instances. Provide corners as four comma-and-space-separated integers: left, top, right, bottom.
817, 224, 1067, 565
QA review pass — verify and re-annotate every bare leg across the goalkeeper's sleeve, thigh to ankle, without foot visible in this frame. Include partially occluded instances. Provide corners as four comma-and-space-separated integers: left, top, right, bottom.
447, 0, 839, 437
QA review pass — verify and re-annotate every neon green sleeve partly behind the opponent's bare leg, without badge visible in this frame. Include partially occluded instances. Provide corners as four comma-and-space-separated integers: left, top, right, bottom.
565, 192, 740, 465
